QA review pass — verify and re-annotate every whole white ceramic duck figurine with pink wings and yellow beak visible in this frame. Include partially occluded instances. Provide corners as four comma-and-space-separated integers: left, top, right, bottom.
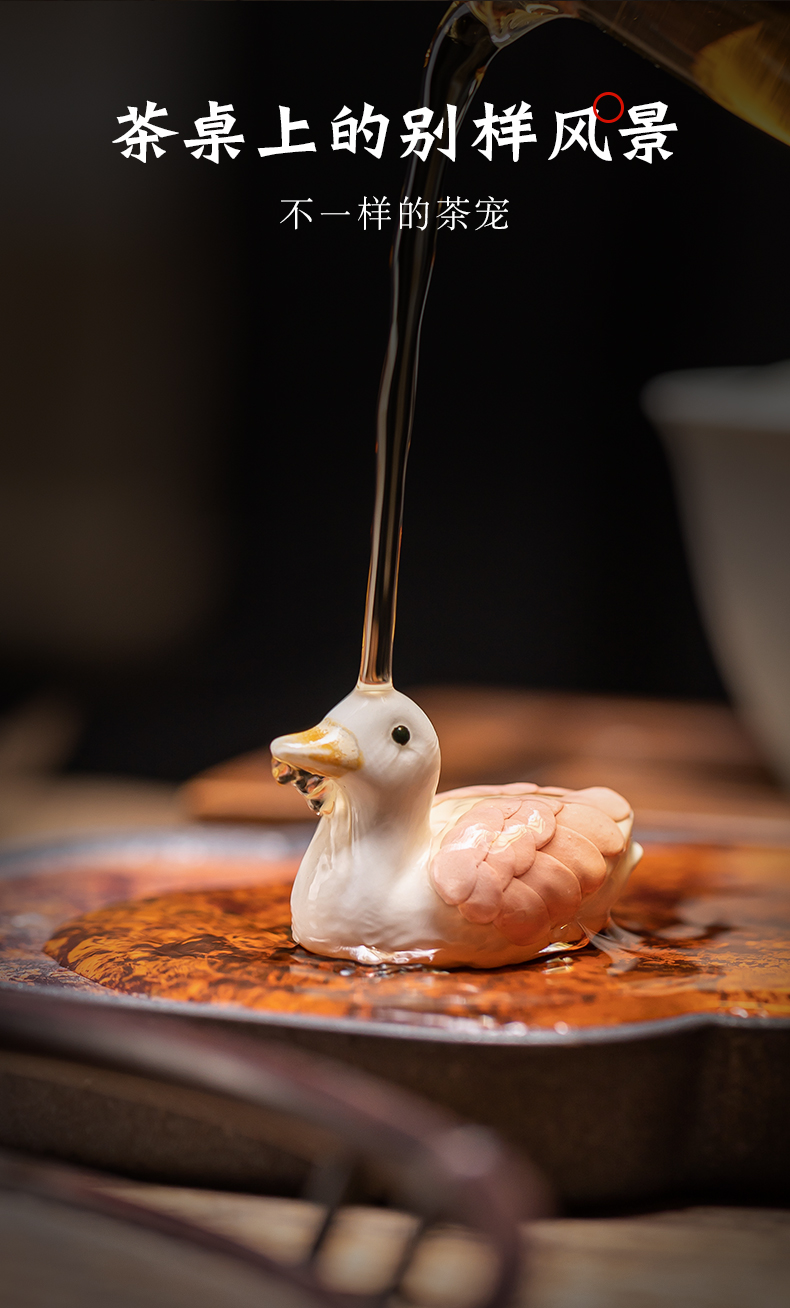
271, 684, 642, 968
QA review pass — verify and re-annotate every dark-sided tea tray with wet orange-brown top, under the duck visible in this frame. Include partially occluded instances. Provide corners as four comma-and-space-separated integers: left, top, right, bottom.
0, 827, 790, 1203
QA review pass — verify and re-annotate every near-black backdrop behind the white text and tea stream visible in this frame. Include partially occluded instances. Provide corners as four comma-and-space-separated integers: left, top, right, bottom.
0, 0, 790, 778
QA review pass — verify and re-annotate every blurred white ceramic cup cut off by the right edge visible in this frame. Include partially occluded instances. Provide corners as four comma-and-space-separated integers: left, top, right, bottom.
642, 362, 790, 786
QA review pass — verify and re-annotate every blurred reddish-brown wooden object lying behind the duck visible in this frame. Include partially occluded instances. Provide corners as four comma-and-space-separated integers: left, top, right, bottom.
182, 687, 790, 844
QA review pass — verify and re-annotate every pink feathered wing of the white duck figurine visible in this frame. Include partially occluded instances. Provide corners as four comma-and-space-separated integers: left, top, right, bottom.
430, 782, 633, 948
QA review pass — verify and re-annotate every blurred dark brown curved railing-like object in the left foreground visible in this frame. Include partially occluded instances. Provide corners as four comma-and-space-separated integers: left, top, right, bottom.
0, 993, 536, 1308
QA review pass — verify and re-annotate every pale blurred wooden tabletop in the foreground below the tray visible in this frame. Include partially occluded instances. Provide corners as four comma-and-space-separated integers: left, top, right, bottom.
90, 1184, 790, 1308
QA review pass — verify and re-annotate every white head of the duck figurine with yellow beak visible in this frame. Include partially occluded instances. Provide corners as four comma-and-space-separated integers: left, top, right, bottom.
271, 684, 441, 820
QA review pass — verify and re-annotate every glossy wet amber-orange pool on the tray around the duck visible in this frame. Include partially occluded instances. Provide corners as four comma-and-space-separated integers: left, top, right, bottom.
30, 845, 790, 1035
